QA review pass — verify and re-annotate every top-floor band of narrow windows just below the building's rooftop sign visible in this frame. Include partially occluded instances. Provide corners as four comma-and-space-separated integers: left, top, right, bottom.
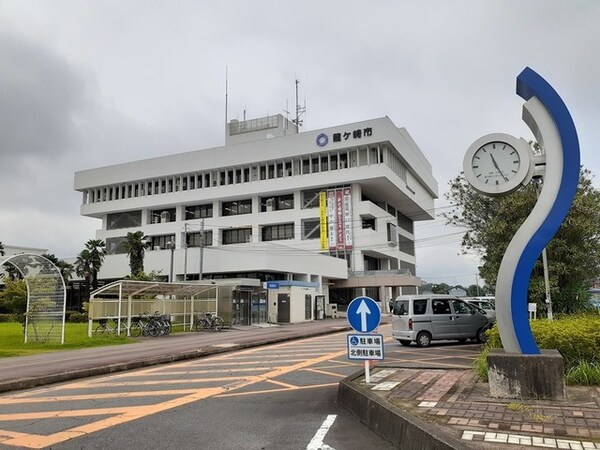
83, 144, 406, 204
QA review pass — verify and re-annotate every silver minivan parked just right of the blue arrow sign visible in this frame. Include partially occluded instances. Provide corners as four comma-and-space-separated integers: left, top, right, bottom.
392, 294, 495, 347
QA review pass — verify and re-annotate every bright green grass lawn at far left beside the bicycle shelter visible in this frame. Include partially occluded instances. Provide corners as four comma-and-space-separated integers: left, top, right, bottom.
0, 322, 135, 358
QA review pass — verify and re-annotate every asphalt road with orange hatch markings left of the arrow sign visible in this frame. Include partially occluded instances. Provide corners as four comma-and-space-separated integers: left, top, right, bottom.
0, 333, 400, 450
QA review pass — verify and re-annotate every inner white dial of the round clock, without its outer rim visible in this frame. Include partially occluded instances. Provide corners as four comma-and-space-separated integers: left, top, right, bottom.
471, 141, 521, 186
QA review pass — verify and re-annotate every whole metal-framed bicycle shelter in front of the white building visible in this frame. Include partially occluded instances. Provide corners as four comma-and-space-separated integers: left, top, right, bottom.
88, 280, 235, 337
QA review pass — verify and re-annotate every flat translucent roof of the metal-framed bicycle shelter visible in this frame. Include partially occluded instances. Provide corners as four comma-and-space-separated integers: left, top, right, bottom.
91, 280, 218, 298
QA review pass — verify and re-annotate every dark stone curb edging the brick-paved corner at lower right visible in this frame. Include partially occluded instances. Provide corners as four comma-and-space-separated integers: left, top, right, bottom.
337, 370, 471, 450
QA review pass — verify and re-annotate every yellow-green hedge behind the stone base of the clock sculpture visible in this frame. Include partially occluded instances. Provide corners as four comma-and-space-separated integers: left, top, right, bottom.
474, 314, 600, 384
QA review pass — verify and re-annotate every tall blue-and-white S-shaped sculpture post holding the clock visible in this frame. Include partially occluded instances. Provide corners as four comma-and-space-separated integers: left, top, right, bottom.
496, 67, 580, 354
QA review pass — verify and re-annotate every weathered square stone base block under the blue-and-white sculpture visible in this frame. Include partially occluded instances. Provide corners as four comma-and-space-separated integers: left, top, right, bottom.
488, 350, 565, 400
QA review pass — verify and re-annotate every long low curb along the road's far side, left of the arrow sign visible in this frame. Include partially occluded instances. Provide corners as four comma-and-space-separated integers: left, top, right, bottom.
0, 327, 350, 392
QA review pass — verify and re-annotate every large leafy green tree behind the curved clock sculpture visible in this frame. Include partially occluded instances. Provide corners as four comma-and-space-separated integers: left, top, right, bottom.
444, 169, 600, 312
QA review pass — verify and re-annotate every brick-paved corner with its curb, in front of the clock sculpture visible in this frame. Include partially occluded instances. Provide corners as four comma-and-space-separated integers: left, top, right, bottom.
338, 364, 600, 450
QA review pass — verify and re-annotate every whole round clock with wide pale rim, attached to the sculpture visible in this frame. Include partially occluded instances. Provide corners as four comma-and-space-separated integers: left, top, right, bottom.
463, 133, 534, 196
